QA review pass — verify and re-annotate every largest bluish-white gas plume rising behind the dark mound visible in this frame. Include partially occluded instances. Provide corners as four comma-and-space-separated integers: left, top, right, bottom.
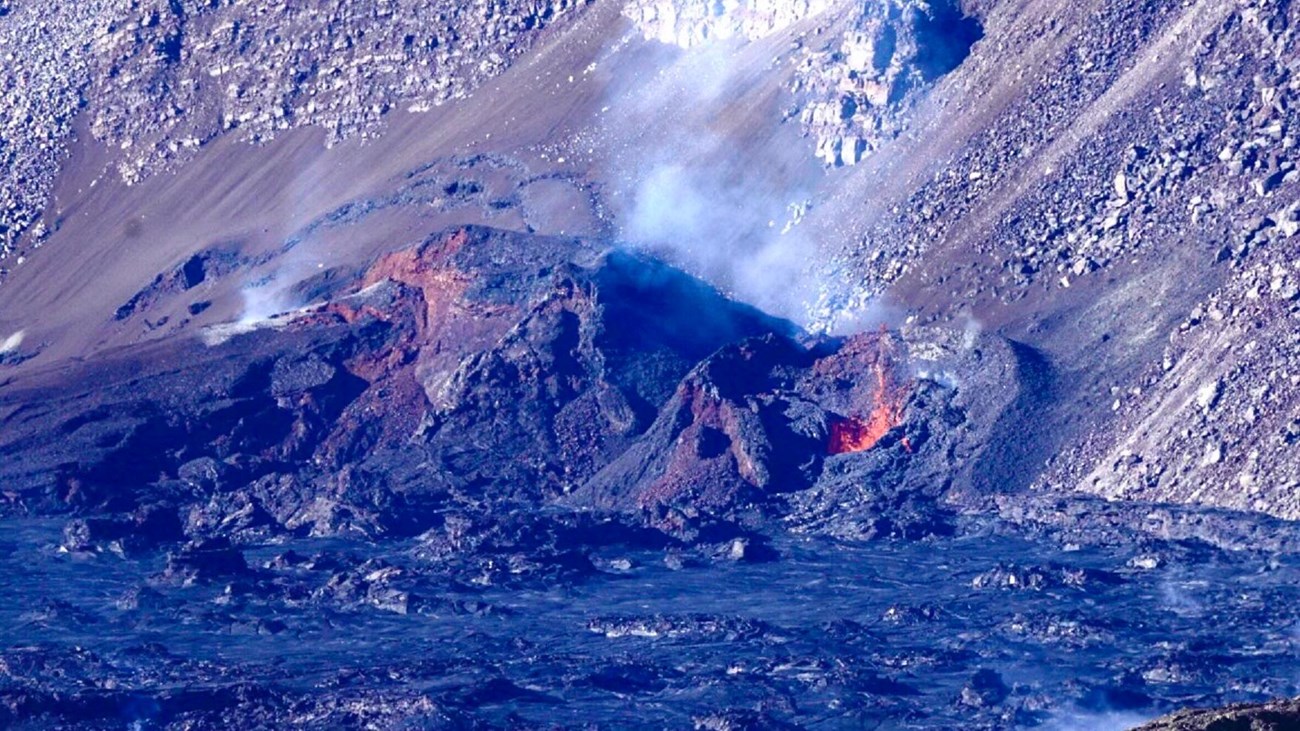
602, 35, 823, 323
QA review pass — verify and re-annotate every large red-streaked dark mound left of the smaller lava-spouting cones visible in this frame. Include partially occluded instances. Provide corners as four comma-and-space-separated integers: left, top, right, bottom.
0, 229, 793, 546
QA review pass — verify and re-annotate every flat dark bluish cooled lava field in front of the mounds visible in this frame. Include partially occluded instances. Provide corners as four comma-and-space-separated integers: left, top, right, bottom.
0, 520, 1300, 728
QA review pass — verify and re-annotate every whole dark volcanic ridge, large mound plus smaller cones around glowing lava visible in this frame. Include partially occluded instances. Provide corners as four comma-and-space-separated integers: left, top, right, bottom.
0, 229, 1014, 548
